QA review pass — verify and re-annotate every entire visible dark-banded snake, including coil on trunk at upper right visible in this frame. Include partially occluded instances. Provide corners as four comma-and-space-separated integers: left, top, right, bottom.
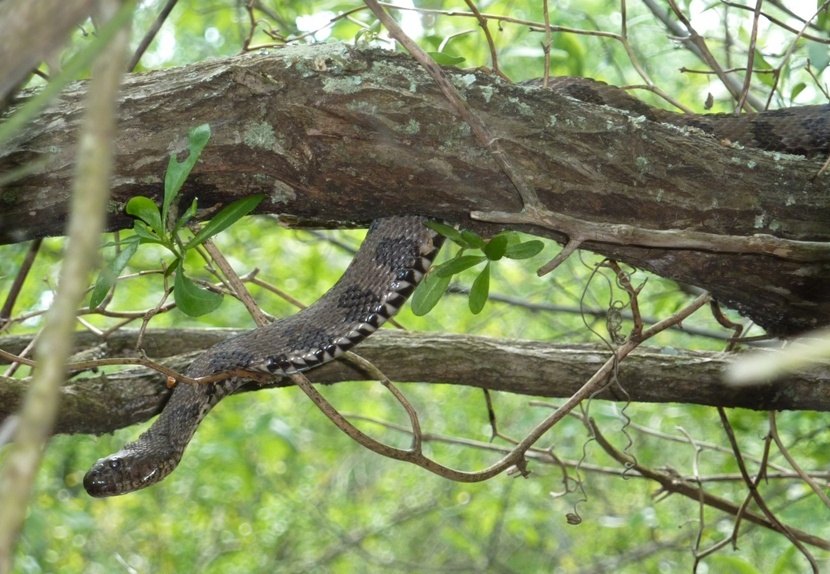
84, 77, 830, 497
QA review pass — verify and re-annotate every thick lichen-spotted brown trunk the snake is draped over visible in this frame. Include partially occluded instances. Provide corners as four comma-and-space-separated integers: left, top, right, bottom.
0, 45, 830, 334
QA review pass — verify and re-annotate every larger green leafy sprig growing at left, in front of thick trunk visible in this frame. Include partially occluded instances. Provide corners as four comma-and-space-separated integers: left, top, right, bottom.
89, 124, 264, 317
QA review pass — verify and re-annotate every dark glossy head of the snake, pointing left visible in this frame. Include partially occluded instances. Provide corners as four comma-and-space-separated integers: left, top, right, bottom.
84, 448, 171, 498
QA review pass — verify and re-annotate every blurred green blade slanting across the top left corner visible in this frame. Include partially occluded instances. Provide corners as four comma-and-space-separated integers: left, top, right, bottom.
0, 2, 135, 148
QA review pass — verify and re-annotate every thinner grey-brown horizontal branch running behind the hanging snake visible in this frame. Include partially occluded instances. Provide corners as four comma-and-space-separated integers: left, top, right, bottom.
0, 329, 830, 434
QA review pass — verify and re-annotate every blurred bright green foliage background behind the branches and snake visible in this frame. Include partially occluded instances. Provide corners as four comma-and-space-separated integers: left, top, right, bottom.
0, 0, 830, 573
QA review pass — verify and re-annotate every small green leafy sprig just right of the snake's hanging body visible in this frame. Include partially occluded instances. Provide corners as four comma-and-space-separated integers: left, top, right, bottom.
412, 221, 544, 316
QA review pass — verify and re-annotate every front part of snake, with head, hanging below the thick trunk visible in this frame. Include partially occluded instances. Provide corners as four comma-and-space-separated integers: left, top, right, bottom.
84, 216, 443, 497
